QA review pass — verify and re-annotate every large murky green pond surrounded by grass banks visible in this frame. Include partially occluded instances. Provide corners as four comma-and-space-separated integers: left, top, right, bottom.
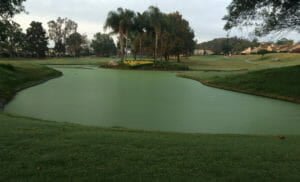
5, 67, 300, 135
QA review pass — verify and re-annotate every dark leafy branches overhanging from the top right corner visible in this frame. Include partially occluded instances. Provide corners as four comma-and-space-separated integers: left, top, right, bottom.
223, 0, 300, 35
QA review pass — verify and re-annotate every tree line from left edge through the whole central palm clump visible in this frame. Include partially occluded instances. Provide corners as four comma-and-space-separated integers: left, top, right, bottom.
0, 0, 195, 61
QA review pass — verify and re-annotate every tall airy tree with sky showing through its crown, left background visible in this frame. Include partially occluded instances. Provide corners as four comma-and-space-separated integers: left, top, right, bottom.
48, 17, 78, 55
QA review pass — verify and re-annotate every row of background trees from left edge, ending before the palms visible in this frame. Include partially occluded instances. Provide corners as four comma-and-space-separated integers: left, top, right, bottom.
0, 17, 116, 58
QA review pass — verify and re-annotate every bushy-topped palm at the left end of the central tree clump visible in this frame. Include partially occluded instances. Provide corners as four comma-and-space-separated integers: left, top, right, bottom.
104, 8, 135, 62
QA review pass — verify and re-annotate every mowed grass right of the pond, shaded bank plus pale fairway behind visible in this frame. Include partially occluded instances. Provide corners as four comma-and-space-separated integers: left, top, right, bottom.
178, 53, 300, 103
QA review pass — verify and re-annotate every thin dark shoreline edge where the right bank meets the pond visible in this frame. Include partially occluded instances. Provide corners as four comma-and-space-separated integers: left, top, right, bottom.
176, 74, 300, 104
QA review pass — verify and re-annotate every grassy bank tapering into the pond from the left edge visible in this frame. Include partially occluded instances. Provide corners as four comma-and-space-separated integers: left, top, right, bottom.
0, 63, 61, 108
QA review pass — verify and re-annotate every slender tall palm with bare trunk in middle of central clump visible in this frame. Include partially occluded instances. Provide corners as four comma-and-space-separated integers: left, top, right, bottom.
146, 6, 162, 61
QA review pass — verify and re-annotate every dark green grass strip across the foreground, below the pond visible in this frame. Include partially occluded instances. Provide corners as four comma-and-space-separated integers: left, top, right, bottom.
0, 114, 300, 181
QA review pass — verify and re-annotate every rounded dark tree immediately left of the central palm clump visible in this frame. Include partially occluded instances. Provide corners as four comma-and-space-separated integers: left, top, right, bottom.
91, 33, 117, 57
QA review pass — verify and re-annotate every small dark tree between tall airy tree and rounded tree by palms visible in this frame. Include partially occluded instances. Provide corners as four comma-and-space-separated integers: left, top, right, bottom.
66, 32, 84, 57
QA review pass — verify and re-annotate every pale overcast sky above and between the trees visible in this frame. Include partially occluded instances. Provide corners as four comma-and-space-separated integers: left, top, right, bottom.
15, 0, 300, 42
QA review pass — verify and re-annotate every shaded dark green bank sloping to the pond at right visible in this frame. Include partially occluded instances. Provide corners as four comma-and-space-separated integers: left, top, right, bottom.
179, 66, 300, 103
